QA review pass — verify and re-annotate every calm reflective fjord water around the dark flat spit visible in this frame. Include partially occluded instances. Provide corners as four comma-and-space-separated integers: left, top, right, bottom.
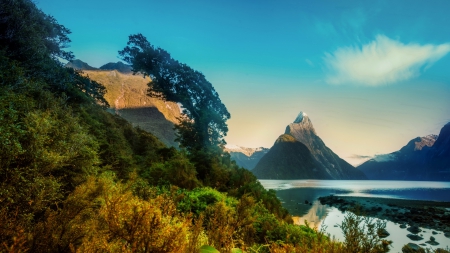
259, 180, 450, 252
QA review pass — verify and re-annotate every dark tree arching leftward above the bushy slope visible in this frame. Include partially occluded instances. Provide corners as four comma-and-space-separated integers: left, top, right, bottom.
119, 34, 230, 154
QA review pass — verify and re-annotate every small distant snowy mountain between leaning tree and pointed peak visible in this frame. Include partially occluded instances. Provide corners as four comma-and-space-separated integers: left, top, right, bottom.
224, 145, 269, 170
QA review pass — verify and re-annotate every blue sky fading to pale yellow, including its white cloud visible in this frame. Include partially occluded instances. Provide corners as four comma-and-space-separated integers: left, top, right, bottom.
35, 0, 450, 165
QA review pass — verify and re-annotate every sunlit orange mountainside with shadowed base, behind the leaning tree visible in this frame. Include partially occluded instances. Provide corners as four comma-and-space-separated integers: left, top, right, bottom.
83, 69, 181, 147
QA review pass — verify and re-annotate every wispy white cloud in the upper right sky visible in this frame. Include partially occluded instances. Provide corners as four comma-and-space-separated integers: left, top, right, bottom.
324, 35, 450, 86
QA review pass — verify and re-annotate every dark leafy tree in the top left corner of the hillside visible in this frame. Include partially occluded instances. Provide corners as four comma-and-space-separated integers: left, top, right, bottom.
0, 0, 108, 107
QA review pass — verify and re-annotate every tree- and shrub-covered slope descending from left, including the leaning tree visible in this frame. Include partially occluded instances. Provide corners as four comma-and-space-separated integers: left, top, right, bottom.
0, 0, 394, 252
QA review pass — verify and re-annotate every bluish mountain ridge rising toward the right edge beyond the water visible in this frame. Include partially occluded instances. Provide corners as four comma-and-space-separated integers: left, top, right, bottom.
358, 123, 450, 181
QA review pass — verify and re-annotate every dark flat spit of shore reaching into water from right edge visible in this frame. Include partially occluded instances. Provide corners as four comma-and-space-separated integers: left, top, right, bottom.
319, 195, 450, 235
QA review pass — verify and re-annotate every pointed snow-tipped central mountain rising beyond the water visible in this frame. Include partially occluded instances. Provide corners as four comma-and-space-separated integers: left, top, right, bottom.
253, 112, 367, 179
